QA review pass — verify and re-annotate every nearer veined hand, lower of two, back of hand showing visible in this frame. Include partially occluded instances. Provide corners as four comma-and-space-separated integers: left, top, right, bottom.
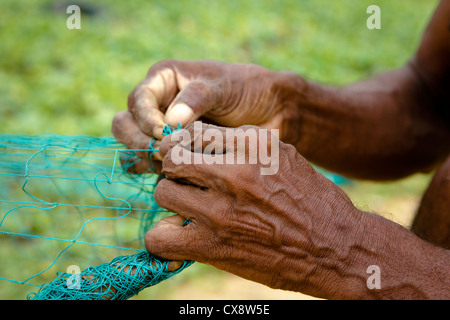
145, 124, 365, 297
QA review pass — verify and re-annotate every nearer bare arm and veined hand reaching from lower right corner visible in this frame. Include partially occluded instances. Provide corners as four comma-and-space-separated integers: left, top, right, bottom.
146, 125, 450, 299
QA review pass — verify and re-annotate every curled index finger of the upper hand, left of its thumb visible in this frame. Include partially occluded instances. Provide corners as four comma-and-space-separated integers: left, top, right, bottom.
128, 64, 178, 139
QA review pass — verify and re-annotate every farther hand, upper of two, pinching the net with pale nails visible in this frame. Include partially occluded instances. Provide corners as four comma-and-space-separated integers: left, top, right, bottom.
112, 60, 300, 173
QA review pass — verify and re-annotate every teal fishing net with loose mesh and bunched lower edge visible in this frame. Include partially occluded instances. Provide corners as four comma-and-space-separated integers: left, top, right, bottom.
0, 128, 192, 300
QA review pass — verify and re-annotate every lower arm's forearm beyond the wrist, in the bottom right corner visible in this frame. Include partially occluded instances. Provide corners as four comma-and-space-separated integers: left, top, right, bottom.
339, 214, 450, 299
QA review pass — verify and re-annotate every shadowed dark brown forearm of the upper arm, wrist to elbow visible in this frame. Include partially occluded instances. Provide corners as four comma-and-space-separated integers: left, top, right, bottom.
280, 65, 450, 180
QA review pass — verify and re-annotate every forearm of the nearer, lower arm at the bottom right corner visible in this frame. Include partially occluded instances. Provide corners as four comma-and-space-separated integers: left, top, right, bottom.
329, 211, 450, 299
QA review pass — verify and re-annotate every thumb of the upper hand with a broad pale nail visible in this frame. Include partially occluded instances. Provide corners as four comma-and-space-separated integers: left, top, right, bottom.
164, 80, 220, 127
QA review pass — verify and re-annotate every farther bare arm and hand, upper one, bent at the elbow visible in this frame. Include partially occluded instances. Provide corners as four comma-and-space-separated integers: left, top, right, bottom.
113, 0, 450, 180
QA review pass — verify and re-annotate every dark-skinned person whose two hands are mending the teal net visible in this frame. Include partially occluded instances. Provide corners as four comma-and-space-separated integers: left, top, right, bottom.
113, 0, 450, 299
